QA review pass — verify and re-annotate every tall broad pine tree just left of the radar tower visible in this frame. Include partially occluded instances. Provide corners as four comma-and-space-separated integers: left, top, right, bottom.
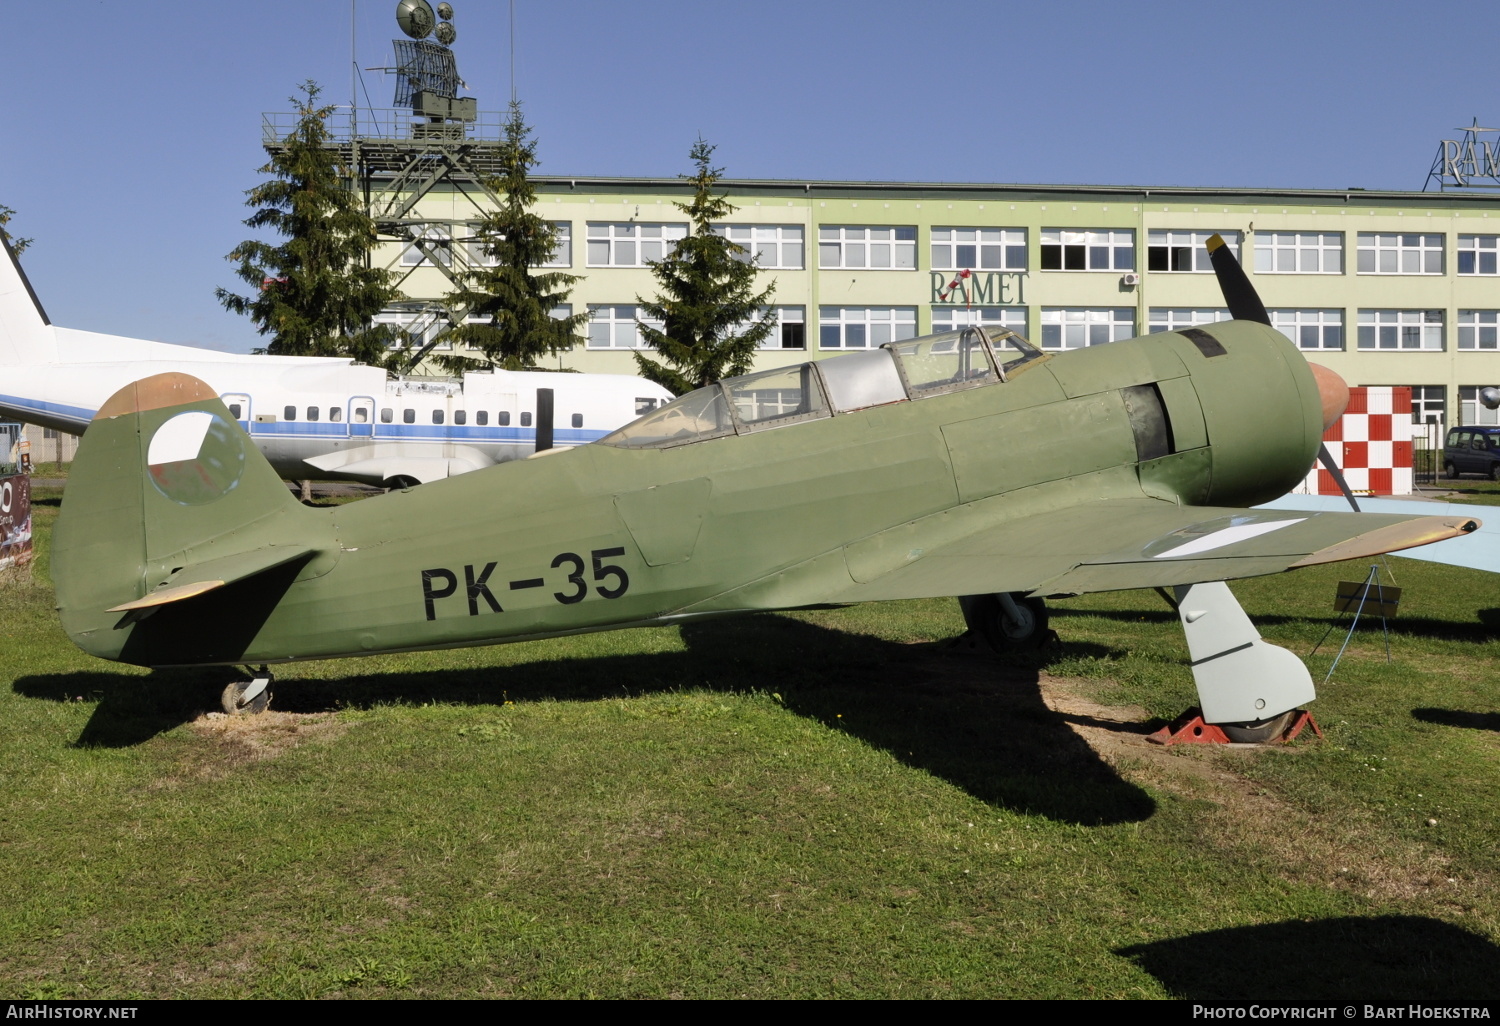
215, 80, 402, 366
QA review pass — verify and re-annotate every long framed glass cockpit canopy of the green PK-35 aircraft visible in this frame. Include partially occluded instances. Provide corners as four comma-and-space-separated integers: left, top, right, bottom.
599, 327, 1043, 449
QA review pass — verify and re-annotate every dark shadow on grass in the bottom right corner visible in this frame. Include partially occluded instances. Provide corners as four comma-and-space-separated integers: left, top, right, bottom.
1115, 915, 1500, 1005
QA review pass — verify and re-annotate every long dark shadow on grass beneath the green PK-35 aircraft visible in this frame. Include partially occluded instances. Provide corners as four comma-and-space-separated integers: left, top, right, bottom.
14, 615, 1155, 825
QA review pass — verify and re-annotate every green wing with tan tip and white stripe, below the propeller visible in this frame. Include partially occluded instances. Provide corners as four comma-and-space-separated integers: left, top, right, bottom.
836, 498, 1481, 602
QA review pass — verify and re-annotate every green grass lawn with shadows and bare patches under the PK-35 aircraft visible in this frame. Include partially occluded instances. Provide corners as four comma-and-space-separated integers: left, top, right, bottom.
0, 480, 1500, 1004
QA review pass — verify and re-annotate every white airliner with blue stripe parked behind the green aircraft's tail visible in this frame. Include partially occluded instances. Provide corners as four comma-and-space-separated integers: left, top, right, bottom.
0, 248, 672, 485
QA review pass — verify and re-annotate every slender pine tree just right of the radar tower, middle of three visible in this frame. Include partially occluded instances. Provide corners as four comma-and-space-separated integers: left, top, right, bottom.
438, 101, 588, 372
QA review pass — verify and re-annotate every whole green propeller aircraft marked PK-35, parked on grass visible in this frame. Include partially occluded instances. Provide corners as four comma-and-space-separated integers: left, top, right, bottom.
53, 237, 1478, 725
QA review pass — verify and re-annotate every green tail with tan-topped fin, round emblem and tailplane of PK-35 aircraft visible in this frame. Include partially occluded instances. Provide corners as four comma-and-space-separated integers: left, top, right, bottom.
53, 374, 339, 666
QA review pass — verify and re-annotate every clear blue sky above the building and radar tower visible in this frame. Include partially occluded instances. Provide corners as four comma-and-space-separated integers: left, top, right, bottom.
0, 0, 1482, 351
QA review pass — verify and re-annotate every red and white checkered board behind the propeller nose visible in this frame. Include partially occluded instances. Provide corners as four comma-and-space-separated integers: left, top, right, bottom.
1293, 386, 1412, 495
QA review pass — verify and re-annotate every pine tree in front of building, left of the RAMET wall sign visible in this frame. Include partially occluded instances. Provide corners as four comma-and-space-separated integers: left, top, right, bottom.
636, 140, 776, 395
